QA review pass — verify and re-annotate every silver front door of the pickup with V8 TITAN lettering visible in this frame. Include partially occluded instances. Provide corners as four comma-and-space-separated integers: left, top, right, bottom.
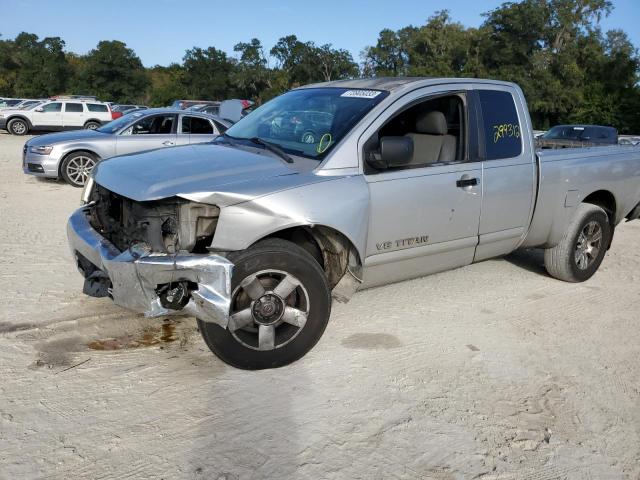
364, 88, 482, 286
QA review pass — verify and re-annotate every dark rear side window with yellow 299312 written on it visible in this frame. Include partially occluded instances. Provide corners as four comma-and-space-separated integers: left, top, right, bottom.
478, 90, 522, 160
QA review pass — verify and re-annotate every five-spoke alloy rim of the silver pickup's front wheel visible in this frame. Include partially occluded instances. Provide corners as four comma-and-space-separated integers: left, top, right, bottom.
227, 269, 310, 351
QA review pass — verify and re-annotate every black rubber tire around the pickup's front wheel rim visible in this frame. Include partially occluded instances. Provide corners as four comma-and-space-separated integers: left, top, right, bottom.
198, 239, 331, 370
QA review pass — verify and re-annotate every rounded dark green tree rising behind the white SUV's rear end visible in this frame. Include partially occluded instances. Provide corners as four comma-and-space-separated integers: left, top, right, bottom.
77, 40, 149, 103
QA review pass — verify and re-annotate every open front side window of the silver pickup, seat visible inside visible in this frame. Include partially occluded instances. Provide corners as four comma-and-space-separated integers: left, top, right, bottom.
365, 94, 467, 173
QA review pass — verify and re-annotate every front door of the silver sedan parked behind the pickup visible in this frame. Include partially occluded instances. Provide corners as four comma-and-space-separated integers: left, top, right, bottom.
116, 114, 177, 155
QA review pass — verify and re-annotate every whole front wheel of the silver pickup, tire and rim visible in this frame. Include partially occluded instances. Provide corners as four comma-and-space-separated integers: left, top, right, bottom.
198, 239, 331, 370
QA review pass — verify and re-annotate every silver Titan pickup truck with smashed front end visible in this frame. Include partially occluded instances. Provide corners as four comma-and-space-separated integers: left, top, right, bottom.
68, 78, 640, 369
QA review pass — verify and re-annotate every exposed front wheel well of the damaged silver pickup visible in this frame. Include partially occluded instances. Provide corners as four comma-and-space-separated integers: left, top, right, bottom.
266, 225, 362, 288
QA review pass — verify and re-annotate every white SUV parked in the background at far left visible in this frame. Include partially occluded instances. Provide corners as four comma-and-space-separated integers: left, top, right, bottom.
0, 100, 113, 135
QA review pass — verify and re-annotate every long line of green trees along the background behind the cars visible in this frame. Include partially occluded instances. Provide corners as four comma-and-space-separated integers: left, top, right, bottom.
0, 0, 640, 133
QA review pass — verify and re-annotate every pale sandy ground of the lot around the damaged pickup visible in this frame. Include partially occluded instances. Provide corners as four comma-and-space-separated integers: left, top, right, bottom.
0, 134, 640, 480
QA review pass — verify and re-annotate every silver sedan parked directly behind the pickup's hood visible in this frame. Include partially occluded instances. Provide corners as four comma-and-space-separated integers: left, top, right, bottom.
22, 109, 231, 187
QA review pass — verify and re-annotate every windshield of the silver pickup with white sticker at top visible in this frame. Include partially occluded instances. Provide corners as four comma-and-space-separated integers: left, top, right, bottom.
218, 88, 388, 160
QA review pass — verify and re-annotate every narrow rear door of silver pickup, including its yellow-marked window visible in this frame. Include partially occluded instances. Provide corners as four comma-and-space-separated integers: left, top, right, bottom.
474, 85, 537, 261
